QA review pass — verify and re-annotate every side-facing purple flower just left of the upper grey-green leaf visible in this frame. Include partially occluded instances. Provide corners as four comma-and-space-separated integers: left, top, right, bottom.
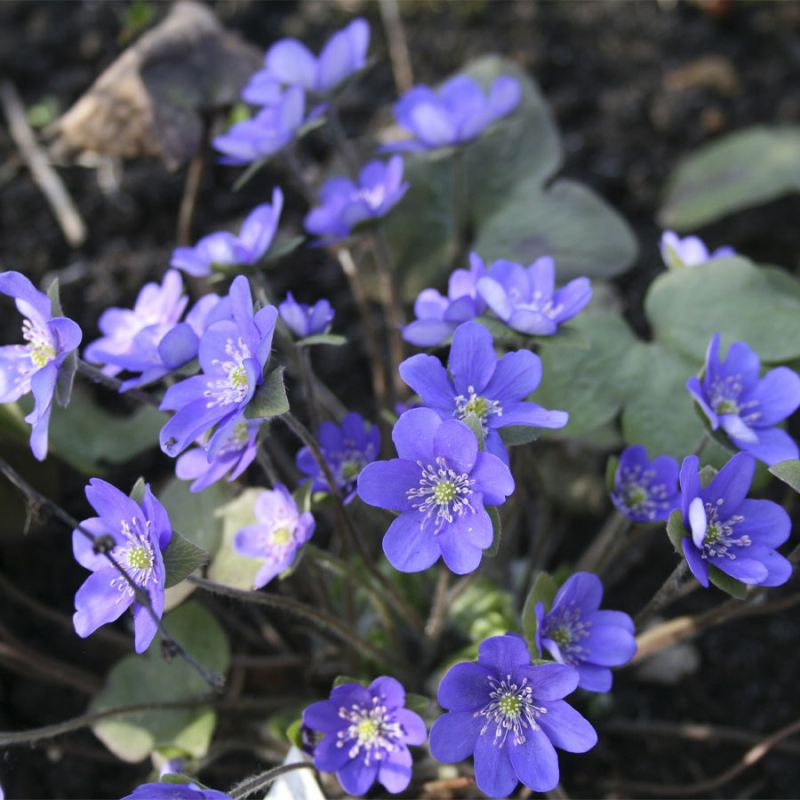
305, 156, 408, 241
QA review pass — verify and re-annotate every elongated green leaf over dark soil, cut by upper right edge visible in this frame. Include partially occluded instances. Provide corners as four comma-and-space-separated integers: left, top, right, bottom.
659, 126, 800, 231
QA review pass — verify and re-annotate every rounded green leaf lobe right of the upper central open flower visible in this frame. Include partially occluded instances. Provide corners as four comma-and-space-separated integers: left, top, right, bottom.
533, 311, 641, 439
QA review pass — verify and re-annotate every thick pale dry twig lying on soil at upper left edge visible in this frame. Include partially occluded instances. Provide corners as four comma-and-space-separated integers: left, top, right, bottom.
0, 80, 86, 247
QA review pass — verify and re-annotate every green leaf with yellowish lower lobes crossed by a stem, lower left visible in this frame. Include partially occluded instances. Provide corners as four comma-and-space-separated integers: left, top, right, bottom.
90, 602, 230, 763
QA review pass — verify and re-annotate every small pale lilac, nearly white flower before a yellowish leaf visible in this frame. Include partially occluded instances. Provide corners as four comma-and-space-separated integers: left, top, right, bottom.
233, 484, 315, 589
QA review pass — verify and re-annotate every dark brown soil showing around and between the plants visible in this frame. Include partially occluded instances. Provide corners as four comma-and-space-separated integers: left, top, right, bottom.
0, 0, 800, 798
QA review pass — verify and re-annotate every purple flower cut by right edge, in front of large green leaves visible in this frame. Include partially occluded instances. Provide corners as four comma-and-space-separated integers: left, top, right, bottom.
686, 333, 800, 466
